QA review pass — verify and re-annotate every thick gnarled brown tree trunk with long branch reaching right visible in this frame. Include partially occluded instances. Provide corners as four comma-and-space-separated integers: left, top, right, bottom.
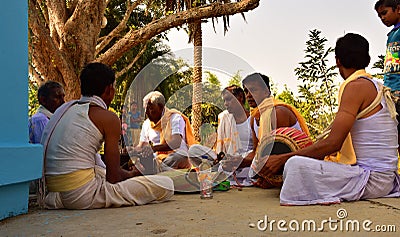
28, 0, 260, 100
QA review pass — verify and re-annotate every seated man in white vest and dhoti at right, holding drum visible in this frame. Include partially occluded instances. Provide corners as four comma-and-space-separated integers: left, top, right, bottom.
261, 33, 400, 205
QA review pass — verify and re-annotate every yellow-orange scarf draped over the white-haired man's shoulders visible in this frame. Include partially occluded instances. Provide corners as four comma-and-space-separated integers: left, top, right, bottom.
150, 107, 197, 160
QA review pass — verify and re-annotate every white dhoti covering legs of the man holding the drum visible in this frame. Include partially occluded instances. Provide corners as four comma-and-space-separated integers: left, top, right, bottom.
280, 156, 400, 205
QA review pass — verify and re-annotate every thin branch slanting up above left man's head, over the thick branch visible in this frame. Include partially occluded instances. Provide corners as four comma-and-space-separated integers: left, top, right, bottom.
95, 0, 143, 56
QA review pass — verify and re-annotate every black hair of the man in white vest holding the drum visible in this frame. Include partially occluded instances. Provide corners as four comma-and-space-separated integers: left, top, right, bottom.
335, 33, 371, 70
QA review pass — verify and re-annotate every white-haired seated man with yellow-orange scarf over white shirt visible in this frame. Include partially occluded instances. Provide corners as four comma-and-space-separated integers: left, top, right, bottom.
135, 91, 195, 171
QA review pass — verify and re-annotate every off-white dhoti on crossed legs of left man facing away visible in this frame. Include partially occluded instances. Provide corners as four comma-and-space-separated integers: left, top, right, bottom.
45, 166, 174, 209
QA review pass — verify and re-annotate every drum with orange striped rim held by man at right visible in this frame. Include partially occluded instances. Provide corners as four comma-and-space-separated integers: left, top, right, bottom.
256, 127, 313, 188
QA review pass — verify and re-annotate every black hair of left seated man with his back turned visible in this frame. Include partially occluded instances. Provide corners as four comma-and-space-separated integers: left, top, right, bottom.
80, 62, 115, 96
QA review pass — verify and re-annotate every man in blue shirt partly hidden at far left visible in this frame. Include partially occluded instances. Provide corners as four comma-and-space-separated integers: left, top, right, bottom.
29, 81, 65, 144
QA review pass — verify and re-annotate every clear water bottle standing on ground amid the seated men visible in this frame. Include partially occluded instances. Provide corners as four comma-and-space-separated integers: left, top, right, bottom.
198, 159, 213, 199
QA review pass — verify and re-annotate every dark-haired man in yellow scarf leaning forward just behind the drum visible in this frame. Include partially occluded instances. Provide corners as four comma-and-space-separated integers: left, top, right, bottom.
242, 73, 310, 188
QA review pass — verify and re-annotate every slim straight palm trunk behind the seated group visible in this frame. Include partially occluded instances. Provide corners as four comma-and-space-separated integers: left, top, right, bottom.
192, 21, 203, 142
